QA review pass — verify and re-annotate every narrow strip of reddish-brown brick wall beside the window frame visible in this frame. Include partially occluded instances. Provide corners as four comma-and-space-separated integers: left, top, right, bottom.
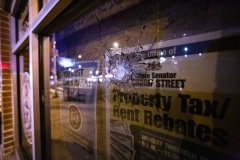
0, 9, 14, 156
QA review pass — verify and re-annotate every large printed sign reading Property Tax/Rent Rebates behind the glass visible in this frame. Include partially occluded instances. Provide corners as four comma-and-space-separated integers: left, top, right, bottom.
109, 33, 240, 160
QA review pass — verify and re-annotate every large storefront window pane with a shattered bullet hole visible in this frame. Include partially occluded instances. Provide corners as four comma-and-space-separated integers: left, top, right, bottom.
50, 1, 240, 160
